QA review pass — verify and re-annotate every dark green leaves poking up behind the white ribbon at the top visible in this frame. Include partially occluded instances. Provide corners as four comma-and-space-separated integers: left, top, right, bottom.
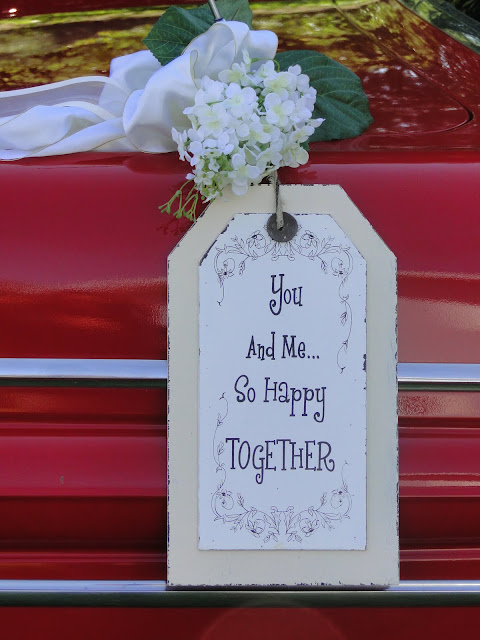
143, 0, 252, 64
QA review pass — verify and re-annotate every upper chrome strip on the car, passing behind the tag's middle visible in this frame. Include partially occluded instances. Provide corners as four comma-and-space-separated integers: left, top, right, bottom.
0, 358, 480, 390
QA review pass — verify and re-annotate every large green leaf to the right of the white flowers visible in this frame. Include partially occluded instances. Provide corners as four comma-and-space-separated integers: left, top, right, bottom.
275, 51, 373, 142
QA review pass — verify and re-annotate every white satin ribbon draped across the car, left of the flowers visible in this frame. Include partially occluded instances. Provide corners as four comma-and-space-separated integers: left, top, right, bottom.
0, 20, 277, 160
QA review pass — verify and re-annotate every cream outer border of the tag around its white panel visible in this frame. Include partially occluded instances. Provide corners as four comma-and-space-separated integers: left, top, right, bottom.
168, 185, 398, 586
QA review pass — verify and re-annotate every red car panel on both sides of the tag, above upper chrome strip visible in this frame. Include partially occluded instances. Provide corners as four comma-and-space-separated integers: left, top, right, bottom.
0, 150, 480, 362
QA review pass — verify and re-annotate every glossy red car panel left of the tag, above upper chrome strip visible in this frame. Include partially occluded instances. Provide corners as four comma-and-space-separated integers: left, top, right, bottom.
0, 153, 190, 358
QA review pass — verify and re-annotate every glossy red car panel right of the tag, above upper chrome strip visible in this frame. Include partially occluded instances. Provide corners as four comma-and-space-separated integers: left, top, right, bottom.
284, 150, 480, 363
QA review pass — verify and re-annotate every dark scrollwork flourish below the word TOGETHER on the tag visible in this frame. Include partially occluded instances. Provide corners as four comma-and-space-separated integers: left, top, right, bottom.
211, 393, 352, 544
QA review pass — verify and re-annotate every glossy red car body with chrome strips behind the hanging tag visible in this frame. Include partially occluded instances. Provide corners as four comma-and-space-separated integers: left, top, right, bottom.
0, 0, 480, 640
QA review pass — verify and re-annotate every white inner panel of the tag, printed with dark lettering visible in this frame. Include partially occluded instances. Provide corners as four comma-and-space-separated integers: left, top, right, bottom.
198, 214, 366, 549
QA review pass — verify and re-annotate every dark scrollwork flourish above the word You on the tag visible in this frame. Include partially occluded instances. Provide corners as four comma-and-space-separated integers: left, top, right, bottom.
214, 220, 353, 371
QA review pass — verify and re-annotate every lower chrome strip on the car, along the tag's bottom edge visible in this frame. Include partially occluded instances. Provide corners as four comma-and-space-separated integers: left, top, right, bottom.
0, 580, 480, 607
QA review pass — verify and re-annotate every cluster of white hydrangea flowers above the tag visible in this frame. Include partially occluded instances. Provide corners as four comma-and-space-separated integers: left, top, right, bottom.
168, 53, 323, 215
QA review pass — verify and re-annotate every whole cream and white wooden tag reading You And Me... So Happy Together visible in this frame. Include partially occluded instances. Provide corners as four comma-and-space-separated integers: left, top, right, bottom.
168, 185, 398, 586
